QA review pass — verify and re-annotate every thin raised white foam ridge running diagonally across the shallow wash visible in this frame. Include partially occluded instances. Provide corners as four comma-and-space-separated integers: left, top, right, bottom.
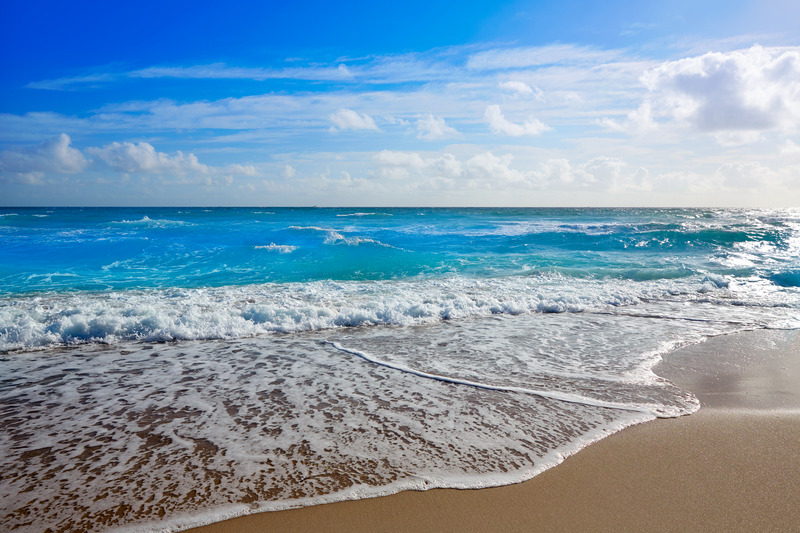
322, 340, 679, 418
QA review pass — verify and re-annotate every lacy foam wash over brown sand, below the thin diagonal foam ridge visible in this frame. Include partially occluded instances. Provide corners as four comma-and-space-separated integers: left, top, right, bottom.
0, 320, 664, 531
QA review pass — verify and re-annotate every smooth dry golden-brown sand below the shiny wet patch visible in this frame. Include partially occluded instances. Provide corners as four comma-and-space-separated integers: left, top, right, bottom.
187, 408, 800, 533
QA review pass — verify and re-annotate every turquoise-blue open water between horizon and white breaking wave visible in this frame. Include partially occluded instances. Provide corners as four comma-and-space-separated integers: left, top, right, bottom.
0, 208, 800, 294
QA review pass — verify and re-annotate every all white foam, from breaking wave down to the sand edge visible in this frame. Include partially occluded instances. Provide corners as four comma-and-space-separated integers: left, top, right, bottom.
0, 275, 800, 532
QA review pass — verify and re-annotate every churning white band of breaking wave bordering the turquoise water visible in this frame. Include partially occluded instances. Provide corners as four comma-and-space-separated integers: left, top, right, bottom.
0, 276, 800, 351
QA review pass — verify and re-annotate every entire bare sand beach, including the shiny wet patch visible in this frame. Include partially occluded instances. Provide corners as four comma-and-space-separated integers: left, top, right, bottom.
184, 332, 800, 533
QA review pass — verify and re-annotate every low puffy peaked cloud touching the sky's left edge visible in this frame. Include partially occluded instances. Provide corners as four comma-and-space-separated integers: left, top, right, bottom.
0, 133, 87, 174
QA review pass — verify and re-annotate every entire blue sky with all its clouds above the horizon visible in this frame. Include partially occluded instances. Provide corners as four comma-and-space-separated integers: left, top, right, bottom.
0, 0, 800, 207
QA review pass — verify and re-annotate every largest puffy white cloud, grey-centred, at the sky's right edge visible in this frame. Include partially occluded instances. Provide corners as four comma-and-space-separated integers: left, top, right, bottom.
641, 46, 800, 137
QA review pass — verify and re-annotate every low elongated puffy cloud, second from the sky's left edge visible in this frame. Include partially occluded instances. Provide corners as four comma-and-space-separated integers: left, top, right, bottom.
86, 142, 209, 175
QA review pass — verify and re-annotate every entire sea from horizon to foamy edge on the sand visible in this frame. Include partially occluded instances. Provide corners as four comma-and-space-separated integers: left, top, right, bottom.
0, 208, 800, 531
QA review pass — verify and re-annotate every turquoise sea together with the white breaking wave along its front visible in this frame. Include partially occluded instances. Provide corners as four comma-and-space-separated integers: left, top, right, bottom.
0, 208, 800, 350
